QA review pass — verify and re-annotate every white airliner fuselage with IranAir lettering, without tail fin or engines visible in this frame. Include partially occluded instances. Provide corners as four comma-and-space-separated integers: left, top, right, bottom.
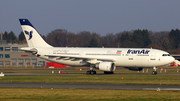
32, 47, 174, 67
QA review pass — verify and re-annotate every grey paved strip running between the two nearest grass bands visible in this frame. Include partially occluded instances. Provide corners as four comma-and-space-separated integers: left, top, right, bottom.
0, 82, 180, 91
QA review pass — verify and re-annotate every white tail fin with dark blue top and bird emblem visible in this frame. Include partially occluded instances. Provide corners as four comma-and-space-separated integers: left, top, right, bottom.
19, 19, 52, 47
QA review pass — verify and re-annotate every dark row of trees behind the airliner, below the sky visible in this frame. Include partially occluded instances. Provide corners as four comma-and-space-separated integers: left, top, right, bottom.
3, 29, 180, 54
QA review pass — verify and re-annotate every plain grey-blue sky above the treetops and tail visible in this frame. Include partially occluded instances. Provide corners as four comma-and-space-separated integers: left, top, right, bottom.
0, 0, 180, 35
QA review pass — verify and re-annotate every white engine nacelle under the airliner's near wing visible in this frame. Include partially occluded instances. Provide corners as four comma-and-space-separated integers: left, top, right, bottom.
95, 62, 116, 72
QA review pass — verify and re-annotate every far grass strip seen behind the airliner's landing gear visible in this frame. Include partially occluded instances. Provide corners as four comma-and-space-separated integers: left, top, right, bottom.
0, 67, 180, 74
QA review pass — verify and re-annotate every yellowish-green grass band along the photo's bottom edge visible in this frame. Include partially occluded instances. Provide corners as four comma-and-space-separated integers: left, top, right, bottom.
0, 89, 180, 101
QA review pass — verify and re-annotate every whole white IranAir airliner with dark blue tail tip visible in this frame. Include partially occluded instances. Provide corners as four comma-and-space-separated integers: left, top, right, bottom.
19, 19, 174, 74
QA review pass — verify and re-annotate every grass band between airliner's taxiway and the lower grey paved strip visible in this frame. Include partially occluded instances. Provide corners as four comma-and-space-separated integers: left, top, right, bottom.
0, 75, 180, 85
